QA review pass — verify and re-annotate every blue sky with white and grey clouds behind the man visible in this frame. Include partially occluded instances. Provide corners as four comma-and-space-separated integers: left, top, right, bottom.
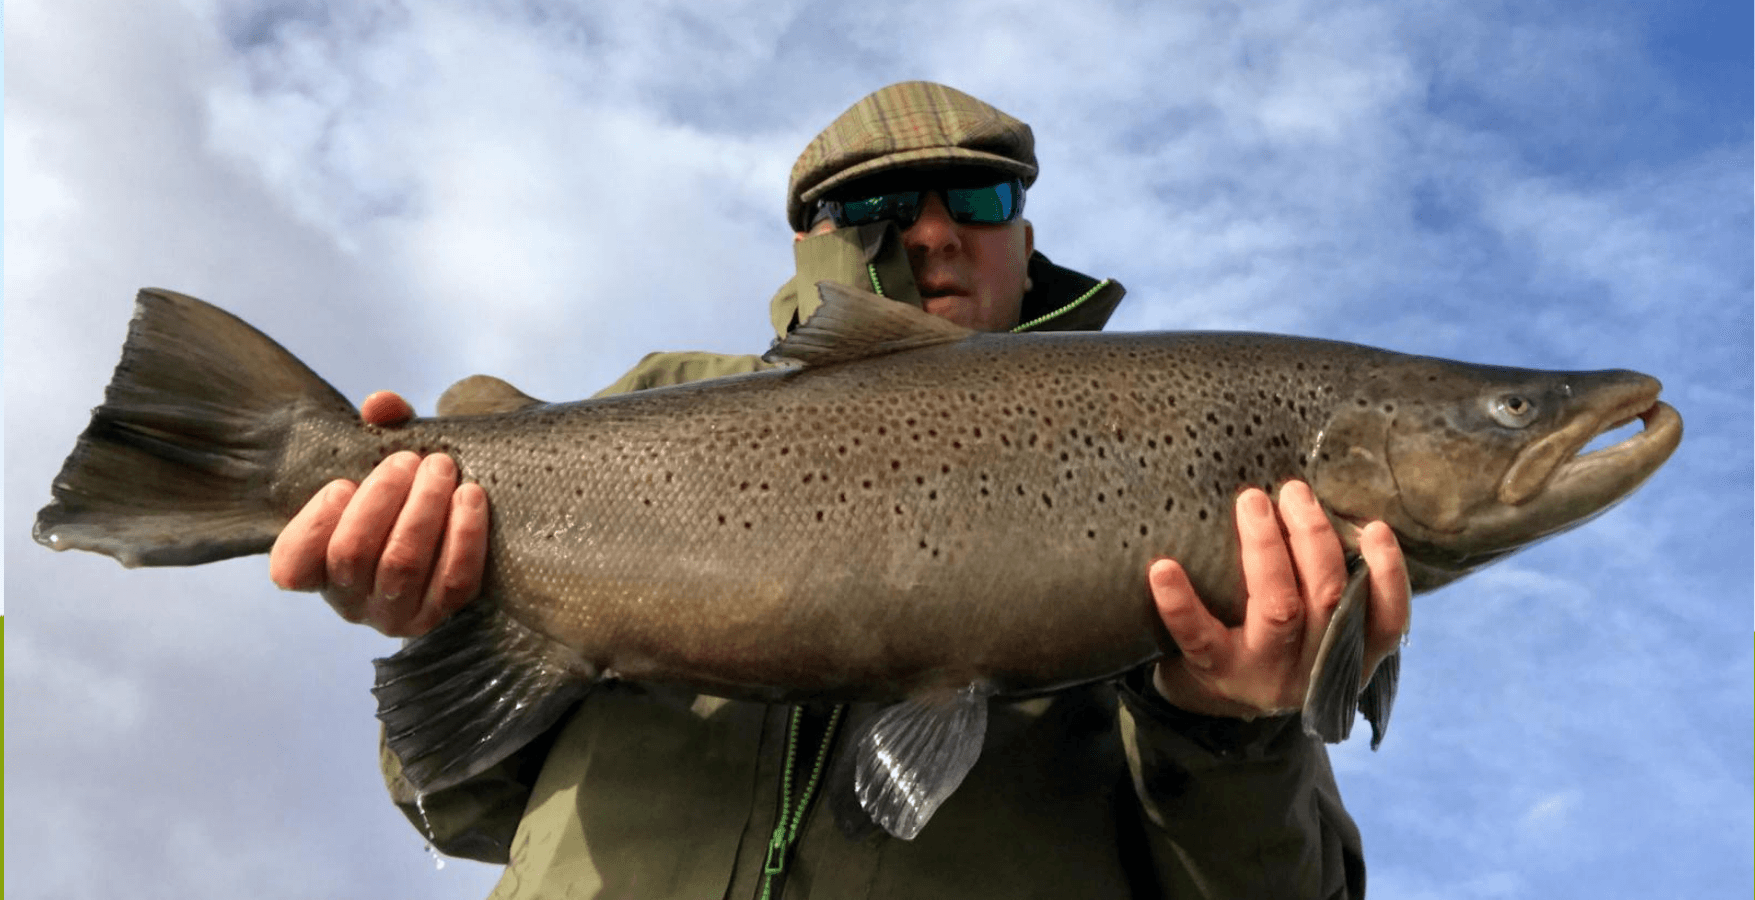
0, 0, 1755, 900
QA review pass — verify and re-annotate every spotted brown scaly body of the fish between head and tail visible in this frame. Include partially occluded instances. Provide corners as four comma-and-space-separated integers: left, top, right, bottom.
270, 335, 1336, 698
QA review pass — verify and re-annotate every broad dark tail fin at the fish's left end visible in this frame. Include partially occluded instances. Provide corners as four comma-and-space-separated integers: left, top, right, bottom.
32, 288, 356, 567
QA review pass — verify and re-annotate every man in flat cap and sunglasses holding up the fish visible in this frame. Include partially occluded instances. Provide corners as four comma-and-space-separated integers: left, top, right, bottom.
270, 82, 1409, 898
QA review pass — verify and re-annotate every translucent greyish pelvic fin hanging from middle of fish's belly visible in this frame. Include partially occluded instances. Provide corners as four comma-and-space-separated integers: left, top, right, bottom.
853, 684, 993, 840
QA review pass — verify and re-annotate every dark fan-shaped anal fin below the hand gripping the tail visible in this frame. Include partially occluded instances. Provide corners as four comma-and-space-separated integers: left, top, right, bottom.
372, 600, 593, 795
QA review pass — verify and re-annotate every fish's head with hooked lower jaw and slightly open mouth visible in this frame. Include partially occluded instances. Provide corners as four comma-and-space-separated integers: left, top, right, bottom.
1309, 358, 1681, 589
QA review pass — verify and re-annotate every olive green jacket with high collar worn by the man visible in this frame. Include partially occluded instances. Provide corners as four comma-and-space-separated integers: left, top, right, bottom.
381, 228, 1365, 900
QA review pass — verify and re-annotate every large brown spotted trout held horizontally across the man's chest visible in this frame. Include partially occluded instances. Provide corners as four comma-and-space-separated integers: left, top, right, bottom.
35, 284, 1681, 837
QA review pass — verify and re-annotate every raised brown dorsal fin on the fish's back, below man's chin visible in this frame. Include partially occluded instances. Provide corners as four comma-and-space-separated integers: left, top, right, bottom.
762, 281, 976, 367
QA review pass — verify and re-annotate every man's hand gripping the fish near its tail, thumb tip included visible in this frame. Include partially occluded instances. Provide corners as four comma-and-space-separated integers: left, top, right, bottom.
269, 391, 488, 637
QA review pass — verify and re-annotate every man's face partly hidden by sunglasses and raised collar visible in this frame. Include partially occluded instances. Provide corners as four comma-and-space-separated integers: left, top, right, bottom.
799, 172, 1035, 332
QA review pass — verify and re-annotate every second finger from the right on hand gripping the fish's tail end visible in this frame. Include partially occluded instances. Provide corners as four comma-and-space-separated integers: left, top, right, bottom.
365, 453, 456, 637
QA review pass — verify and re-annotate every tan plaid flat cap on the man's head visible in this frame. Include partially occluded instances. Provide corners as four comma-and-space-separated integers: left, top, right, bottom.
786, 81, 1035, 232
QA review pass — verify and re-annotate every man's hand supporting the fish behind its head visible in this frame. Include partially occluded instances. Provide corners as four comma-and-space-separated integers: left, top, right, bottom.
1148, 481, 1409, 719
